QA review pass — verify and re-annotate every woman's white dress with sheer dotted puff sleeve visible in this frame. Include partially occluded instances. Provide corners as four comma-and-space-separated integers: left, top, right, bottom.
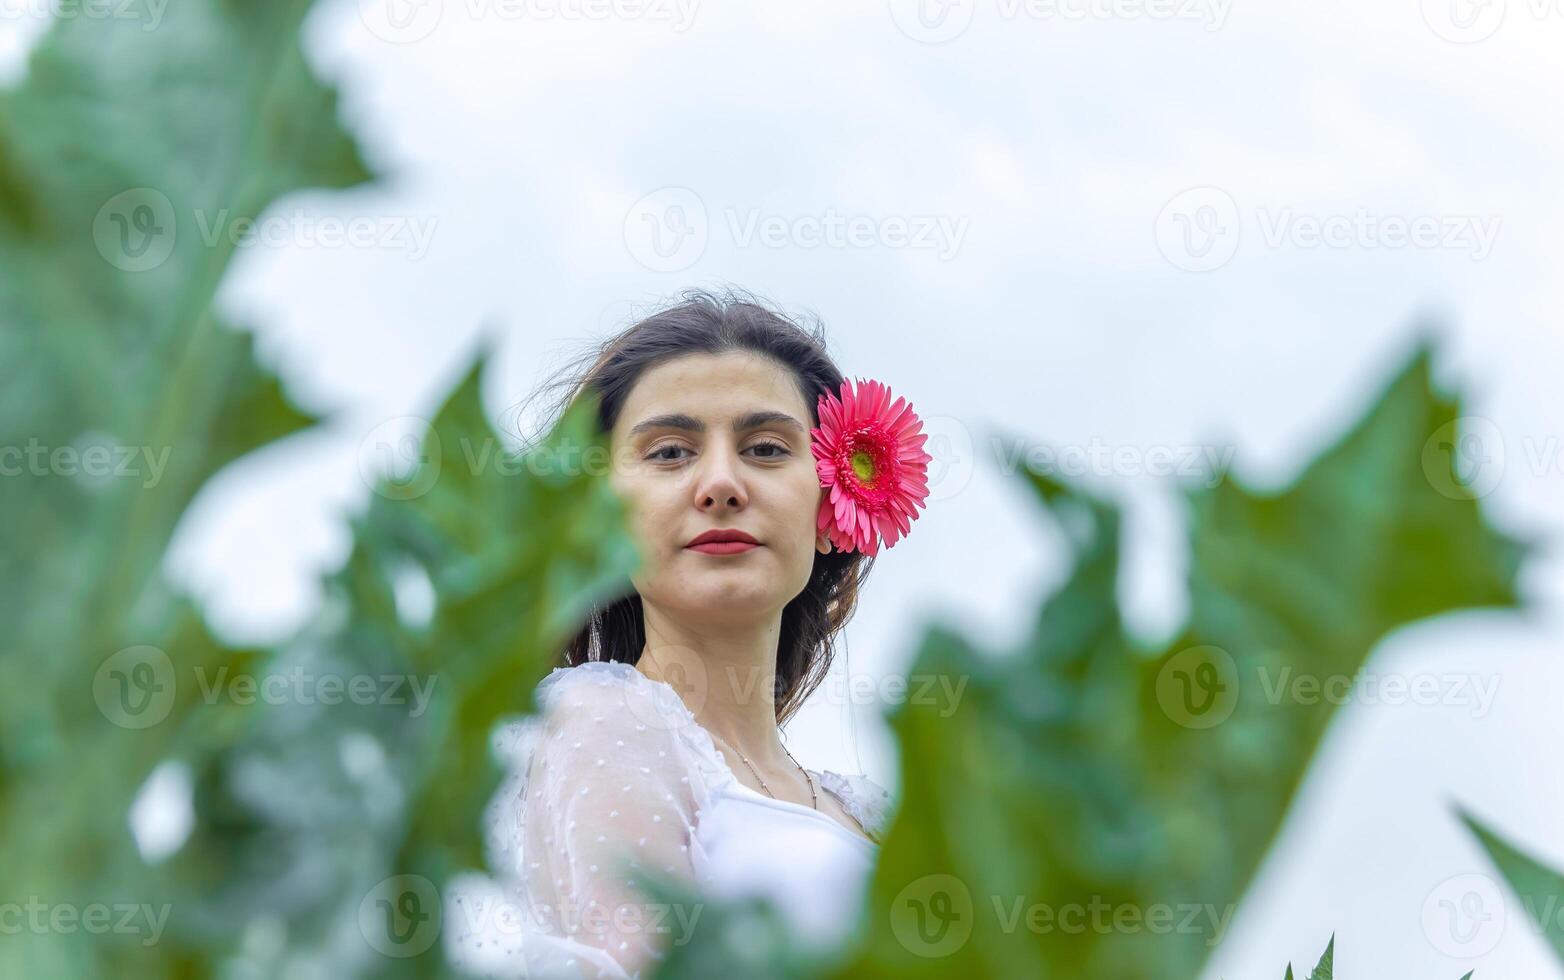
457, 661, 890, 977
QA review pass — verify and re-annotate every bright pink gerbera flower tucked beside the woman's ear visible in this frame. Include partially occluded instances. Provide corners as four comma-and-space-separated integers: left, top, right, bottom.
809, 378, 934, 555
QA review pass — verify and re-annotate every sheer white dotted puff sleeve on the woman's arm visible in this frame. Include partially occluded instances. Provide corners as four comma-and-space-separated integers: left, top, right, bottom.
511, 663, 730, 977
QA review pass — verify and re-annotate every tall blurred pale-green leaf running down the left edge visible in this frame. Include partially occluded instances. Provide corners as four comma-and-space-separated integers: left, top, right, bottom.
0, 0, 368, 977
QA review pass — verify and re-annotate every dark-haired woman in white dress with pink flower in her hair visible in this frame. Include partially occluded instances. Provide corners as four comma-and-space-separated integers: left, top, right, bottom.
487, 292, 929, 977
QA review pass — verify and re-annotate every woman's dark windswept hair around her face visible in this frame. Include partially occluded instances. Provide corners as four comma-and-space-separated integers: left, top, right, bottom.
522, 289, 873, 724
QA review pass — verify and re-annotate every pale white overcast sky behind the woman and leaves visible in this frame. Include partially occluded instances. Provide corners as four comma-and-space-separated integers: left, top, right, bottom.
12, 0, 1564, 980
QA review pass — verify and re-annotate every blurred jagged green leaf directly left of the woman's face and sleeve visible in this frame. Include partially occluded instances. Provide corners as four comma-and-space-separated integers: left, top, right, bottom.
170, 350, 638, 977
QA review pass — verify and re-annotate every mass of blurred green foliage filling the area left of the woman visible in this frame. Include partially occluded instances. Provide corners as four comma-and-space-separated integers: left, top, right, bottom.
0, 0, 635, 977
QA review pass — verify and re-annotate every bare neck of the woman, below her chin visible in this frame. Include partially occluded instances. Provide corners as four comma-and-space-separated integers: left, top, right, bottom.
635, 606, 791, 769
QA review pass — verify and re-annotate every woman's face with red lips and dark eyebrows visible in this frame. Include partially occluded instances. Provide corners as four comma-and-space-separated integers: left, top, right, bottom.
610, 352, 830, 621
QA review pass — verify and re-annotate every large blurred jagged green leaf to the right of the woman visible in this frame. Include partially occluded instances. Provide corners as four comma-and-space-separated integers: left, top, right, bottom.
841, 345, 1523, 980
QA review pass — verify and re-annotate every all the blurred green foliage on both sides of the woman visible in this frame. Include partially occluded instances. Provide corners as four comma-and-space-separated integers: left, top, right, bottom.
0, 0, 1538, 980
